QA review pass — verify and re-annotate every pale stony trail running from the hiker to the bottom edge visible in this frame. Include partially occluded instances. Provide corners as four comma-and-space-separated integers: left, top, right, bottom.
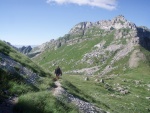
53, 81, 107, 113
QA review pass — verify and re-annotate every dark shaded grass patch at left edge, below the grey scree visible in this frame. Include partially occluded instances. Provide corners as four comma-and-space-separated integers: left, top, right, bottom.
0, 69, 39, 99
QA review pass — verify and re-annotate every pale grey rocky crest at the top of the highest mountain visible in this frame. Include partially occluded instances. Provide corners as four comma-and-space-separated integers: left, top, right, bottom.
69, 15, 136, 34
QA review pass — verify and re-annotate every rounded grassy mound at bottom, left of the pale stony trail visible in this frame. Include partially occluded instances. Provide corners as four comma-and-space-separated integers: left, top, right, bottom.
13, 91, 77, 113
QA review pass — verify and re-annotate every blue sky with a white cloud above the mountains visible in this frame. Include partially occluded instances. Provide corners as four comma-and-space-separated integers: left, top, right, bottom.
0, 0, 150, 45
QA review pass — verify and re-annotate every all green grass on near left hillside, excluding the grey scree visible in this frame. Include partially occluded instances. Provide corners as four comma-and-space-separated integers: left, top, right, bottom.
0, 41, 77, 113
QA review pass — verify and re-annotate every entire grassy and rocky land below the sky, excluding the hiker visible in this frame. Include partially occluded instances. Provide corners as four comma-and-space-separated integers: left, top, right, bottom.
0, 15, 150, 113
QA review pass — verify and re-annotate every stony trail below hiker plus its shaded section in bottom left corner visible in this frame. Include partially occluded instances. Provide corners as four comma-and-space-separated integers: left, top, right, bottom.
0, 81, 107, 113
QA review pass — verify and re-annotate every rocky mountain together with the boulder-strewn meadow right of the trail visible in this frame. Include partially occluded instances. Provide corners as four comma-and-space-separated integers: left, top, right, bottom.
32, 15, 150, 113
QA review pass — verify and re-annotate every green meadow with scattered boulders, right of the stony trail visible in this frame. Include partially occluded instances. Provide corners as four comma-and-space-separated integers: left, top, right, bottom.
63, 58, 150, 113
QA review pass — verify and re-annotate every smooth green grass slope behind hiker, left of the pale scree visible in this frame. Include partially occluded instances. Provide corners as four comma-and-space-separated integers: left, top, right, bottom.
34, 39, 99, 71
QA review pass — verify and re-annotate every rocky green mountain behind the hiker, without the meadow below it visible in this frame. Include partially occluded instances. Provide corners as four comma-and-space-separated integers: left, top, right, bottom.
32, 15, 150, 75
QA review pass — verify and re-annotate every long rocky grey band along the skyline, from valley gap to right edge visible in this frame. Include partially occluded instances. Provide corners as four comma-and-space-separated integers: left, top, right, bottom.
29, 15, 150, 56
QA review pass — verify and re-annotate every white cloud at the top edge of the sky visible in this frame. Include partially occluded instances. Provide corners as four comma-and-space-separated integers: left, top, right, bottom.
47, 0, 117, 10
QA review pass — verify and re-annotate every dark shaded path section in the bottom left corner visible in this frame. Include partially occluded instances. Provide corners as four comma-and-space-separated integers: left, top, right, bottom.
0, 96, 18, 113
